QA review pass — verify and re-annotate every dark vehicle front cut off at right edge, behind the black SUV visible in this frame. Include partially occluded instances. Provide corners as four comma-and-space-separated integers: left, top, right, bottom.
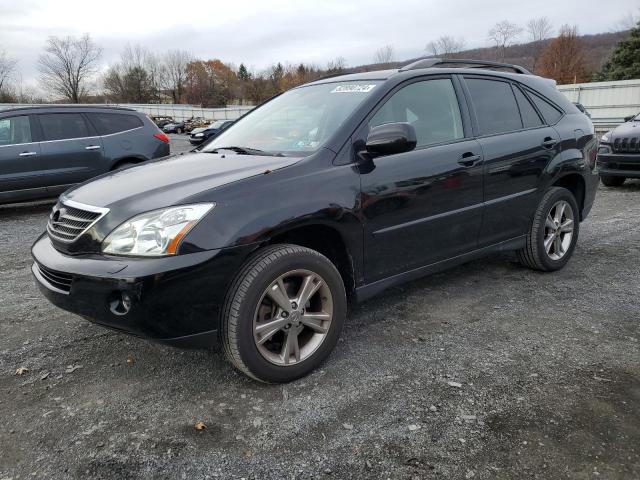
598, 114, 640, 187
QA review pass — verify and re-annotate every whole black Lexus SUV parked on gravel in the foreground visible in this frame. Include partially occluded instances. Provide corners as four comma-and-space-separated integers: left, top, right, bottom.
32, 59, 598, 382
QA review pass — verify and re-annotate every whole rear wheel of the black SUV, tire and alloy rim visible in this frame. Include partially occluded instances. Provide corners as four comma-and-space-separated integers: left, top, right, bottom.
516, 187, 580, 272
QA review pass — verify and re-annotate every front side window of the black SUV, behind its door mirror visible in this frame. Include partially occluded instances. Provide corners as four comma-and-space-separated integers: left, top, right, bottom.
369, 78, 464, 147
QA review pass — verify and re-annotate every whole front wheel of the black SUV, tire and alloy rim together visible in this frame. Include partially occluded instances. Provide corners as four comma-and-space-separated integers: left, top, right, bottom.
220, 244, 347, 383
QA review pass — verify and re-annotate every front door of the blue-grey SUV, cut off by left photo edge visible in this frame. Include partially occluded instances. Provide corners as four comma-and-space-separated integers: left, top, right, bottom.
0, 115, 45, 200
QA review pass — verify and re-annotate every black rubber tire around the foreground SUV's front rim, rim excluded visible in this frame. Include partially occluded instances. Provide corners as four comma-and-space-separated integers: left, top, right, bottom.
220, 244, 347, 383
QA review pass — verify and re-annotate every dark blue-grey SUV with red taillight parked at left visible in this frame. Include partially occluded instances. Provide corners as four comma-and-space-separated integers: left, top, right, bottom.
0, 106, 169, 203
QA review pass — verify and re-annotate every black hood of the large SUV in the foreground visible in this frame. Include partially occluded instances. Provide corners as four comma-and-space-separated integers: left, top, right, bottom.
64, 153, 300, 214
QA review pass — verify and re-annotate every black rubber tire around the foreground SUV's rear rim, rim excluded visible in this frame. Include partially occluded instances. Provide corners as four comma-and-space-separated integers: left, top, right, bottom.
516, 187, 580, 272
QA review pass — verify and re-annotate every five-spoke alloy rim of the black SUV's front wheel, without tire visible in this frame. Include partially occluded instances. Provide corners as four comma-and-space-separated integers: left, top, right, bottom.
253, 270, 333, 366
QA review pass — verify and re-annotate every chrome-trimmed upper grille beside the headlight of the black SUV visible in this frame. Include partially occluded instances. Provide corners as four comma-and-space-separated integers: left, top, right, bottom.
47, 201, 108, 243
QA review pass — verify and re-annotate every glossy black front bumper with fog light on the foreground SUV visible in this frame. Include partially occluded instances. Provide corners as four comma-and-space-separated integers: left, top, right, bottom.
32, 235, 254, 346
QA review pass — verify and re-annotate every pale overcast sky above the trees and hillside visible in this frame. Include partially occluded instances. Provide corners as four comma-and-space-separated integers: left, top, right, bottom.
0, 0, 640, 90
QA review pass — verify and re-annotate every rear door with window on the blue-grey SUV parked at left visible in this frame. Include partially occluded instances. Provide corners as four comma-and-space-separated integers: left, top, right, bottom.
37, 113, 102, 193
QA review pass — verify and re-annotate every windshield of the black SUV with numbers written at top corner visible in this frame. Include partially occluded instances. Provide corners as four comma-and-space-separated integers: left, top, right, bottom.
202, 80, 380, 156
